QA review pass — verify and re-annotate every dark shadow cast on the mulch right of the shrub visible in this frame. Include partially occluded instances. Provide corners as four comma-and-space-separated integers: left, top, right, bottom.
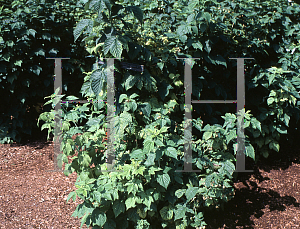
204, 135, 300, 229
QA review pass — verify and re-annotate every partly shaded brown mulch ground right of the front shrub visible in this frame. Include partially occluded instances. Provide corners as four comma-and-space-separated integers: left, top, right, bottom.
205, 138, 300, 229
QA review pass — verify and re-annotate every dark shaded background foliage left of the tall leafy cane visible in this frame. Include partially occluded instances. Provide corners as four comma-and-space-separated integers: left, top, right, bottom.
0, 0, 95, 143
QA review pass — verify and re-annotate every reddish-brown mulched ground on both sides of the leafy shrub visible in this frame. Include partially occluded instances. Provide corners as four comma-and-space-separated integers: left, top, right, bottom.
0, 133, 300, 229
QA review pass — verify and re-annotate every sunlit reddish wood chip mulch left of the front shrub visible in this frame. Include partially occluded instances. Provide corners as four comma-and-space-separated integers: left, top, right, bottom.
0, 138, 87, 229
